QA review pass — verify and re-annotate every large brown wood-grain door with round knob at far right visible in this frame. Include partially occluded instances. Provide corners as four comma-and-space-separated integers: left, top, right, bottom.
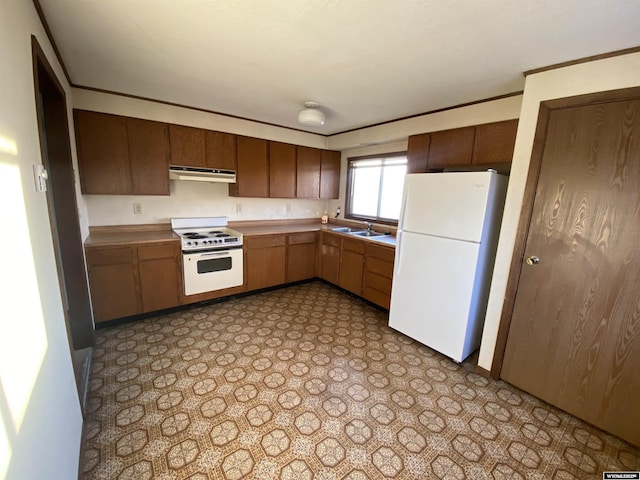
501, 99, 640, 445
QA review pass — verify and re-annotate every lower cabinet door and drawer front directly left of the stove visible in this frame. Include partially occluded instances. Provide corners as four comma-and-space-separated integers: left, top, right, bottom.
138, 243, 182, 312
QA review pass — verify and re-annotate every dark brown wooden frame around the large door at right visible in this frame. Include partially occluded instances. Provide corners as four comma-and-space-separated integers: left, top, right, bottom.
490, 87, 640, 379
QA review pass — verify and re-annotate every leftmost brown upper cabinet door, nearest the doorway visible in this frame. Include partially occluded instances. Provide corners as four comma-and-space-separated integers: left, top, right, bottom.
74, 110, 132, 195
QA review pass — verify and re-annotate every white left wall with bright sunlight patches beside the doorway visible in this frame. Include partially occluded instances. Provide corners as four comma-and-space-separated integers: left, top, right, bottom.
0, 0, 82, 480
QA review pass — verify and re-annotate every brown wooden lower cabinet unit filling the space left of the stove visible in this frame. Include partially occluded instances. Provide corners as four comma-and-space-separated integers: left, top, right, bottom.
87, 242, 182, 322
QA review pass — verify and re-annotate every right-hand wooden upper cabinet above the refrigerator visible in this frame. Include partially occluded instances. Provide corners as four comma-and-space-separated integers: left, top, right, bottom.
472, 120, 518, 165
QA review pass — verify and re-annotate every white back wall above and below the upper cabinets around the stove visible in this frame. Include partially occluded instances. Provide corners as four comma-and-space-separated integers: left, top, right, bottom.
73, 89, 327, 226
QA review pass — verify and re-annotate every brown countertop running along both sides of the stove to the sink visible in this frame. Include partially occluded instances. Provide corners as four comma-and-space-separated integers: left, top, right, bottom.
84, 219, 396, 248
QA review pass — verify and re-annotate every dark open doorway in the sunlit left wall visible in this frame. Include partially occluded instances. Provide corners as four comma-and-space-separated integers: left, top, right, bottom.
31, 36, 95, 406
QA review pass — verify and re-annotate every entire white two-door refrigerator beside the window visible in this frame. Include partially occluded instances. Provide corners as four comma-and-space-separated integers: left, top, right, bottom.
389, 171, 507, 362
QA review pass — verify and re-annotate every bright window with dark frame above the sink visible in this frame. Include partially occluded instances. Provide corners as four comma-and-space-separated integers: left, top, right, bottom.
345, 152, 407, 224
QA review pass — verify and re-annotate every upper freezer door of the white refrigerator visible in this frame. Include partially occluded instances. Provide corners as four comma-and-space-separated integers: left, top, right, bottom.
398, 172, 496, 242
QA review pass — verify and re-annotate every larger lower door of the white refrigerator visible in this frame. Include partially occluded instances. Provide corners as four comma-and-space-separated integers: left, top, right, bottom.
389, 231, 484, 362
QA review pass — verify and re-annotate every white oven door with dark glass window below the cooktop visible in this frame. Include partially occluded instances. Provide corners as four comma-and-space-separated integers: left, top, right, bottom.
182, 248, 244, 295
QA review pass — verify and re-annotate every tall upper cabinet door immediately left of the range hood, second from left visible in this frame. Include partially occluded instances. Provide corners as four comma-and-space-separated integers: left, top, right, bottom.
127, 118, 170, 195
